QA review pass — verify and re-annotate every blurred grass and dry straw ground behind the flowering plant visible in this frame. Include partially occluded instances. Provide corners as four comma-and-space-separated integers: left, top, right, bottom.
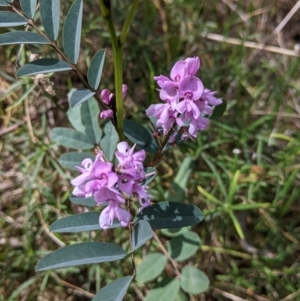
0, 0, 300, 301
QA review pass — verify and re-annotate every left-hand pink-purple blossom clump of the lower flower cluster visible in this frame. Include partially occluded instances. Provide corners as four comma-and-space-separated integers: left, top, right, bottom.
71, 154, 118, 197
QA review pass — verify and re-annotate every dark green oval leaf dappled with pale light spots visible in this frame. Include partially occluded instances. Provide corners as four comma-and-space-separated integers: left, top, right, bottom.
134, 202, 204, 229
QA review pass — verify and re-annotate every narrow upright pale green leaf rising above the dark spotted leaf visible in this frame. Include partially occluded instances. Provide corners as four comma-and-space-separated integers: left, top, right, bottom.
166, 157, 194, 202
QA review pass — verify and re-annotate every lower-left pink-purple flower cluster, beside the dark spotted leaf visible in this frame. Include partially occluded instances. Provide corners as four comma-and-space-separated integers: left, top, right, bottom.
71, 142, 151, 229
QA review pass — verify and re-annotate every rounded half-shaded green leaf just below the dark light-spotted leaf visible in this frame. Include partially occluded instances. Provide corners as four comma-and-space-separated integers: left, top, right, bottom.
168, 231, 201, 261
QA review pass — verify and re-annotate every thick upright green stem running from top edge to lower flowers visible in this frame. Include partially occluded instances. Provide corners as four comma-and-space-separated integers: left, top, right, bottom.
99, 0, 124, 141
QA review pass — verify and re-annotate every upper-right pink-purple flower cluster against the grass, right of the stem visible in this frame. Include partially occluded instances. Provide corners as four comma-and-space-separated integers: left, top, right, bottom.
146, 57, 222, 139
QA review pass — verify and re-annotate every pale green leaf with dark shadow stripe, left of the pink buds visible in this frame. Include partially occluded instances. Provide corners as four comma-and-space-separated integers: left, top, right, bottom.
67, 98, 102, 144
